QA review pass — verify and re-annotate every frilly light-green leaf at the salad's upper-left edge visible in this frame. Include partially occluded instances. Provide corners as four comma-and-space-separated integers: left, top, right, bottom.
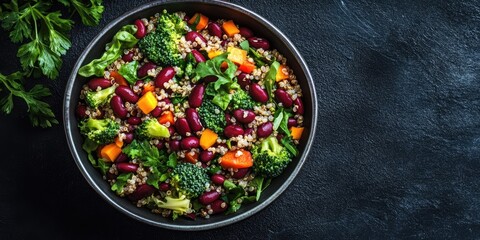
78, 25, 138, 77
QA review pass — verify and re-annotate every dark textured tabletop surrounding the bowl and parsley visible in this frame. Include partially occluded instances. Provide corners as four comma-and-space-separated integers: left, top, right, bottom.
0, 0, 480, 239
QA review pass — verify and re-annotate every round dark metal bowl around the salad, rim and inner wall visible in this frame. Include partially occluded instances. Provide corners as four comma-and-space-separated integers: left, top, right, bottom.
63, 1, 317, 230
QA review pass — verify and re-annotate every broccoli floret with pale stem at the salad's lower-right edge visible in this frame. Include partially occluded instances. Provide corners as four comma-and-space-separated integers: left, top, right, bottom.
252, 136, 292, 178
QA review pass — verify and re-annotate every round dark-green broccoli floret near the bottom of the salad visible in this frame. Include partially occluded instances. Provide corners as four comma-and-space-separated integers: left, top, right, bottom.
170, 163, 210, 198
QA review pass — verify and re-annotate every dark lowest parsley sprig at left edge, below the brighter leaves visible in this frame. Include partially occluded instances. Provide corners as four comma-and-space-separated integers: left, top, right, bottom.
0, 72, 58, 128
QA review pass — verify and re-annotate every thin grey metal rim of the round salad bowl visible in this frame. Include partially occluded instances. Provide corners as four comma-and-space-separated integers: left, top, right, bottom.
63, 0, 318, 231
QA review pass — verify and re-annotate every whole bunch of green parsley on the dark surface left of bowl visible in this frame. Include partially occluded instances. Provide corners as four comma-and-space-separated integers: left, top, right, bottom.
0, 0, 104, 128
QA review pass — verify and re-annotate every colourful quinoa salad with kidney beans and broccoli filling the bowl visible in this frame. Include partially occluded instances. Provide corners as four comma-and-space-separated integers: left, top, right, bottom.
76, 10, 304, 220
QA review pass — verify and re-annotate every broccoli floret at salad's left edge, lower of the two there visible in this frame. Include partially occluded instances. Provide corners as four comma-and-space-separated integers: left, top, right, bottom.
78, 118, 120, 144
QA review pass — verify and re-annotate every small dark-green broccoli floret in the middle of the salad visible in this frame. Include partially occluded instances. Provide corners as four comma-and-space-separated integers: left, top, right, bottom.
198, 100, 227, 134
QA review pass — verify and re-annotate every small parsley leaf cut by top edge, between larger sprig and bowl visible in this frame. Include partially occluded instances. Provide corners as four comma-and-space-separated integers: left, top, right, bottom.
58, 0, 104, 26
